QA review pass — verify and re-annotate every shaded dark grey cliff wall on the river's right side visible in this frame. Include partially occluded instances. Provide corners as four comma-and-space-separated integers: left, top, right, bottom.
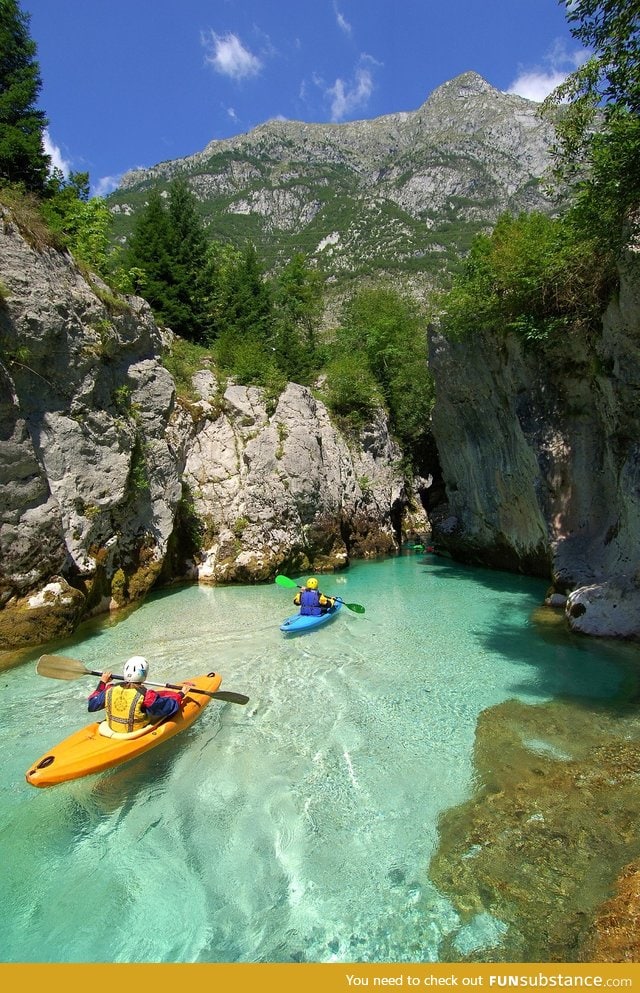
430, 229, 640, 638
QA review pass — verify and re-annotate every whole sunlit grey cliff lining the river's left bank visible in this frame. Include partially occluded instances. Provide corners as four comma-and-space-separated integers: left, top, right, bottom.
0, 210, 426, 649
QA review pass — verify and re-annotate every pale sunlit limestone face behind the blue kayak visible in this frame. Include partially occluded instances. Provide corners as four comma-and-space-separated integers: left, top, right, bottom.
178, 375, 427, 582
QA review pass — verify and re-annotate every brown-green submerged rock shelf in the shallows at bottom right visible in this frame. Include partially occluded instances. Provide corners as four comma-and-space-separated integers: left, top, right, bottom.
430, 688, 640, 962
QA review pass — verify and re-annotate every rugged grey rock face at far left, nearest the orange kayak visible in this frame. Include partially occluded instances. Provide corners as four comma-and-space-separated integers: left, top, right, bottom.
0, 205, 181, 648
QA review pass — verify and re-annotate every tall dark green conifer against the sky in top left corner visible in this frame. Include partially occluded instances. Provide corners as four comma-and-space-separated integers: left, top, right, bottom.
0, 0, 51, 193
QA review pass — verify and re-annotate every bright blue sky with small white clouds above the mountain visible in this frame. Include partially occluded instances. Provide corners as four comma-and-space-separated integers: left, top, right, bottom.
20, 0, 585, 194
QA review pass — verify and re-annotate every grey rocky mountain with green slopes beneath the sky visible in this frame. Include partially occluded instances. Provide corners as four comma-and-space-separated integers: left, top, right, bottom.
108, 71, 555, 285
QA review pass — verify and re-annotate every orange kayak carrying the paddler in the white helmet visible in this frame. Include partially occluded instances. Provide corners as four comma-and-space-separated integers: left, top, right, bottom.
26, 673, 222, 786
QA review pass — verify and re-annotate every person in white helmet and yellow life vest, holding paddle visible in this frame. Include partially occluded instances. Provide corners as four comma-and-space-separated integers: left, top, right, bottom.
88, 655, 192, 734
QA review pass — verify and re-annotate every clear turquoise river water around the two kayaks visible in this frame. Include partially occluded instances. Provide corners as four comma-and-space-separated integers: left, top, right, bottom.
0, 555, 622, 962
